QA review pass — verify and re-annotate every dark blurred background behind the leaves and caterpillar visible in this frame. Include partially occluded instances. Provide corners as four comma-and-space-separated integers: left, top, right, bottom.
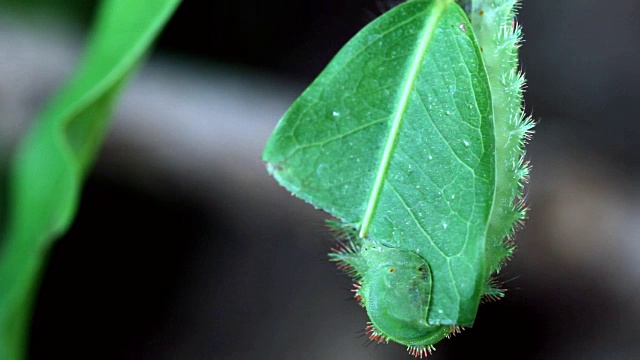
0, 0, 640, 359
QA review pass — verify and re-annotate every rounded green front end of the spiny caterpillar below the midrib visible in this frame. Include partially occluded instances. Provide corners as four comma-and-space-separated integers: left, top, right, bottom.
357, 245, 451, 357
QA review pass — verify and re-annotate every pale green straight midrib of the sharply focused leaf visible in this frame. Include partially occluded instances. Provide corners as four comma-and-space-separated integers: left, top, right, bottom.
359, 0, 450, 238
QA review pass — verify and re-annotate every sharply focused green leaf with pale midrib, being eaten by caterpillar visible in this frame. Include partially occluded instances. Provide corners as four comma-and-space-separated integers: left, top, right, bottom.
263, 0, 495, 326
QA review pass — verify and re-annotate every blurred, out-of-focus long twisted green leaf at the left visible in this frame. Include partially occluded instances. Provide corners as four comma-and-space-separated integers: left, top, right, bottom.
0, 0, 180, 360
